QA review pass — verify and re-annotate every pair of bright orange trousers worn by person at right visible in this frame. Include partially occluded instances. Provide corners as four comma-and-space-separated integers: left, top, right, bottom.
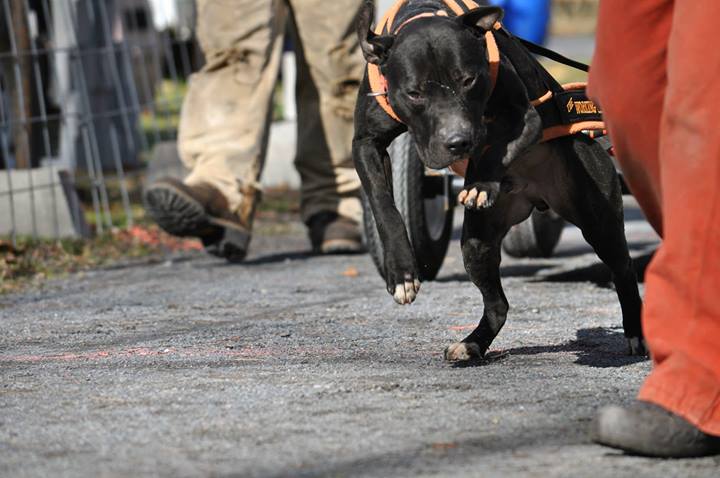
589, 0, 720, 435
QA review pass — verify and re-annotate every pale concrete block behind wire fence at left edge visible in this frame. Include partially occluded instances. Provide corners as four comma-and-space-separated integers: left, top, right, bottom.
0, 167, 89, 238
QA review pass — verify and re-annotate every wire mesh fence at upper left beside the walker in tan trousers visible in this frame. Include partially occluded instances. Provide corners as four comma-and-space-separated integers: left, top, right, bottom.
0, 0, 199, 242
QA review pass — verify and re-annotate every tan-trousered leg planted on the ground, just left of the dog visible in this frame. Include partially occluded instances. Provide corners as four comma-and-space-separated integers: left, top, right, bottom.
289, 0, 365, 249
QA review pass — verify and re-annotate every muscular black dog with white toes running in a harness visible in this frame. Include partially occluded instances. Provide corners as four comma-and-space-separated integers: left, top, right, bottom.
353, 0, 645, 360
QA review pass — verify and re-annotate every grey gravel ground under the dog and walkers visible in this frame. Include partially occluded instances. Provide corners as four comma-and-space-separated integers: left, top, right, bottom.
0, 204, 720, 478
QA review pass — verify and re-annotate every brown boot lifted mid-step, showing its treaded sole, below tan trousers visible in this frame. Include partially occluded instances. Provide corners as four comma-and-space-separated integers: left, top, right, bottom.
145, 178, 256, 262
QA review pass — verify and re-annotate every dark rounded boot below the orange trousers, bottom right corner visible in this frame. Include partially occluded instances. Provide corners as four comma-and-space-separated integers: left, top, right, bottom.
592, 401, 720, 458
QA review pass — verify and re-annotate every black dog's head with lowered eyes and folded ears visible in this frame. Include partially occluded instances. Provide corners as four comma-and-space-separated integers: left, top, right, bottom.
358, 2, 536, 169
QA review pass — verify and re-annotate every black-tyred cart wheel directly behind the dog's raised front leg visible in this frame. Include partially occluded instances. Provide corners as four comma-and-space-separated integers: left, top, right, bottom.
362, 133, 454, 281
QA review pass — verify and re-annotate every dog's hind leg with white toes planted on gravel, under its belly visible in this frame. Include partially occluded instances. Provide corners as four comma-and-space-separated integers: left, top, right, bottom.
445, 200, 532, 361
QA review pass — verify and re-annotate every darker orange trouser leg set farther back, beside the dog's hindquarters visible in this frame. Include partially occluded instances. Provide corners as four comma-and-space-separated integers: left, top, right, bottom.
588, 0, 673, 234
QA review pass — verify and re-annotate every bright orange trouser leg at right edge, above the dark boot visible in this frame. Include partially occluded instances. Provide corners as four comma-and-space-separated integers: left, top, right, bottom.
640, 0, 720, 435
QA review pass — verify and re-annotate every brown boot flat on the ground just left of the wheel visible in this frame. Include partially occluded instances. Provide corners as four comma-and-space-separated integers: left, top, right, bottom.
307, 211, 363, 254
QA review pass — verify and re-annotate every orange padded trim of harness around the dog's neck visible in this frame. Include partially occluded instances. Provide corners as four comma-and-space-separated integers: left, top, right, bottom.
367, 0, 501, 123
